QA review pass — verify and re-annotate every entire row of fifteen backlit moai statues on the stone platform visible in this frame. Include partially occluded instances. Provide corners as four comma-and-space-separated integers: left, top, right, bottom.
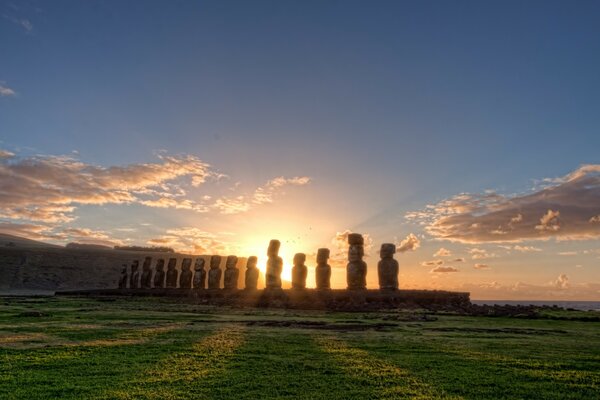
119, 233, 399, 290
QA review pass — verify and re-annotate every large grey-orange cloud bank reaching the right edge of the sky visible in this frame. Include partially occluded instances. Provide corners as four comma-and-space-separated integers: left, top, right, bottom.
406, 164, 600, 244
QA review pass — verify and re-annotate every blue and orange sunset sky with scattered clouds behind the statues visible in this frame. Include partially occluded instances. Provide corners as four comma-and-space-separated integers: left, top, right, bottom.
0, 0, 600, 300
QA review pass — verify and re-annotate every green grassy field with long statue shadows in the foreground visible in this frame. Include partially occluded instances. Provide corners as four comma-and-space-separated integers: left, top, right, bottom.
0, 298, 600, 399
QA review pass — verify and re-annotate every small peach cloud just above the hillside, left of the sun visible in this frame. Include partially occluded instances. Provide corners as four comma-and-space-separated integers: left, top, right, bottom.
147, 227, 233, 255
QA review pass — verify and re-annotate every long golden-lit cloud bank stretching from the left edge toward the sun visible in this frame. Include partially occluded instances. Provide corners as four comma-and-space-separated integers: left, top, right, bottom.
0, 150, 310, 223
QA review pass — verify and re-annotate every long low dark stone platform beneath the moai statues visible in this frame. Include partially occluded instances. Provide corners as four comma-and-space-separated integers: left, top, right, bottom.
56, 289, 471, 311
